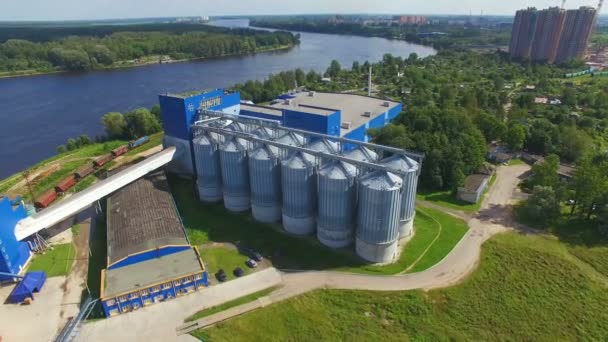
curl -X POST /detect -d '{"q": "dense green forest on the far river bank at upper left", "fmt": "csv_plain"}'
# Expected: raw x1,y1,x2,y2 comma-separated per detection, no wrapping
0,24,299,73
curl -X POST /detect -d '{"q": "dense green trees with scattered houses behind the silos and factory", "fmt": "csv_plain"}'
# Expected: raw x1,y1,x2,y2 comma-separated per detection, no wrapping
229,50,608,189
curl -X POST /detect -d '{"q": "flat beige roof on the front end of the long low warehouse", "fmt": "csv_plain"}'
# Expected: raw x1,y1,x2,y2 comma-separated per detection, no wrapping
103,248,203,298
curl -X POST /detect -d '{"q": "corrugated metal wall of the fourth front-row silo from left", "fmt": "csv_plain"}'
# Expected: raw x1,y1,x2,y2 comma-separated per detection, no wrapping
281,154,317,218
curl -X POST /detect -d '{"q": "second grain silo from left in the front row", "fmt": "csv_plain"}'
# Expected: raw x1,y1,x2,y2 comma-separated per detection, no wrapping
220,136,250,212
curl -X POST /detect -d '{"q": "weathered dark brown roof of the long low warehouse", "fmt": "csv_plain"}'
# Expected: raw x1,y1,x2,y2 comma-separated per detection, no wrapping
107,170,189,265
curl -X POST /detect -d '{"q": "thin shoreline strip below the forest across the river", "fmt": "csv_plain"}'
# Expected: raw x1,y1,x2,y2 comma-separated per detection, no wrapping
0,44,297,79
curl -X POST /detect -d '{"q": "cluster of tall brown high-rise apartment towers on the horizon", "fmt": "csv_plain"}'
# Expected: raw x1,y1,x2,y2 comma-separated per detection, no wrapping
509,7,597,63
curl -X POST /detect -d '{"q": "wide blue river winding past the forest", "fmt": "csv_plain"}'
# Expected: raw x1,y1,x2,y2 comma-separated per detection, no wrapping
0,20,435,179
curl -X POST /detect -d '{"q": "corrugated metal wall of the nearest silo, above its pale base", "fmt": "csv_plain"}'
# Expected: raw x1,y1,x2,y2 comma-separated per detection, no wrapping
357,172,402,244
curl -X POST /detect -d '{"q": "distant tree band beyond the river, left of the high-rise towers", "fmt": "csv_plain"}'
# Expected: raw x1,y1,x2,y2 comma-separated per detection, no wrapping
251,17,511,50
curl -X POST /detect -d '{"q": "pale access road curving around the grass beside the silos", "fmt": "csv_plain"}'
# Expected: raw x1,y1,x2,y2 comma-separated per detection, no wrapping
185,165,530,327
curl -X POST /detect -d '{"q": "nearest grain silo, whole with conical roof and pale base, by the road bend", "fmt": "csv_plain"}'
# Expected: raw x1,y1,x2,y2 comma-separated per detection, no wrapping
355,171,403,263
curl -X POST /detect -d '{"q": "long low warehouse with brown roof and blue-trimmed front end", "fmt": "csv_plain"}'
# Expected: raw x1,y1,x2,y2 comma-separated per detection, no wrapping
100,170,208,317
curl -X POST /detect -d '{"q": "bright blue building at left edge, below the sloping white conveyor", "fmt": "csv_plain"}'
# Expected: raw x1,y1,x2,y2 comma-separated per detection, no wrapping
0,197,32,281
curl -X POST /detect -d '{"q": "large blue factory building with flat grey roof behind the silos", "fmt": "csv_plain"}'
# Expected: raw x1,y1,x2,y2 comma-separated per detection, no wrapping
159,89,403,175
